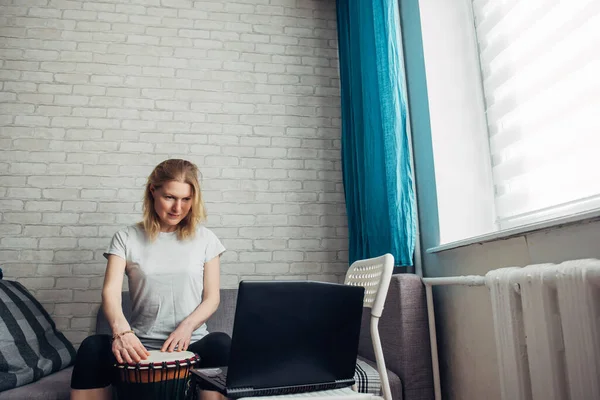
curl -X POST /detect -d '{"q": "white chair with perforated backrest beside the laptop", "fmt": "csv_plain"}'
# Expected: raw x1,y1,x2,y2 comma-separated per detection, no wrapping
344,253,394,400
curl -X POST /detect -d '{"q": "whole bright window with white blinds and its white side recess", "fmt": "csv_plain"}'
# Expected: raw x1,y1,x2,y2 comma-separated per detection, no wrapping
418,0,600,251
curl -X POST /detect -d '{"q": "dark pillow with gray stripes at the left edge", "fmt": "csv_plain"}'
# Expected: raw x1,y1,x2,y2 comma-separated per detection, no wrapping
0,280,75,392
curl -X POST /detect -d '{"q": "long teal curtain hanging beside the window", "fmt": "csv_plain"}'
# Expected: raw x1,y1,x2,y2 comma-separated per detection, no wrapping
337,0,416,266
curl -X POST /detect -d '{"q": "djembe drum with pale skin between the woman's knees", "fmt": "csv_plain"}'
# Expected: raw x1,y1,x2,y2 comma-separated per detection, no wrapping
115,350,200,400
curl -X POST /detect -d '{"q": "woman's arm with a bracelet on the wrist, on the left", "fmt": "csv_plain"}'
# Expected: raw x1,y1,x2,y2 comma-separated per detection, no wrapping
102,254,150,364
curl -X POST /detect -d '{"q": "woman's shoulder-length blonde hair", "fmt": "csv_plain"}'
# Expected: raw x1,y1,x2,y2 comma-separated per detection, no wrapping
139,159,206,241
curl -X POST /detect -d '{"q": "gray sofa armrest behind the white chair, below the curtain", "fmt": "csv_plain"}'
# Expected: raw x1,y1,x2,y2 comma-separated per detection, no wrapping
358,274,434,400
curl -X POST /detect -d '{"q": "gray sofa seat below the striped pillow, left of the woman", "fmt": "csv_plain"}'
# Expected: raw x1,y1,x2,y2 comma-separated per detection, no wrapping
0,367,73,400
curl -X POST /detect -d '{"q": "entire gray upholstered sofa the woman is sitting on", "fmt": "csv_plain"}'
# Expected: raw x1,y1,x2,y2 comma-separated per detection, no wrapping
0,274,434,400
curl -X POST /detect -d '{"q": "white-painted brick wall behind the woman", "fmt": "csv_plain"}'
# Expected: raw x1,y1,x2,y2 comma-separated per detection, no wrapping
0,0,347,343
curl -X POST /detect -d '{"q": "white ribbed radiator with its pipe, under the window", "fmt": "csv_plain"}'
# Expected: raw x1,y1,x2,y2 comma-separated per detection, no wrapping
423,260,600,400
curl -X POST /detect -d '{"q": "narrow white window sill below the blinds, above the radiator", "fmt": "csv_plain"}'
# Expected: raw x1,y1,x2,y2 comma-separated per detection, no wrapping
427,209,600,254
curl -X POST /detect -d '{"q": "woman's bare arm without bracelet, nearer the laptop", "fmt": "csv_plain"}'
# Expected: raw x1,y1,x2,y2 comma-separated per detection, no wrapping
161,256,221,352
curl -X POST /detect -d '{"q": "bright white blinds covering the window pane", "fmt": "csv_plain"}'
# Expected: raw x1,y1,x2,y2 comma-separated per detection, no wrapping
473,0,600,228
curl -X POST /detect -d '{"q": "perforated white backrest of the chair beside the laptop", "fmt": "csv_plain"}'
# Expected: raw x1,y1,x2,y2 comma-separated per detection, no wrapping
344,253,394,317
